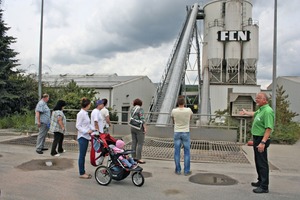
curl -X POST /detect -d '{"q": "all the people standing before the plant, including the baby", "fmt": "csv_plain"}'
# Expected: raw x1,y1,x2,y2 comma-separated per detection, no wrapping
36,92,275,193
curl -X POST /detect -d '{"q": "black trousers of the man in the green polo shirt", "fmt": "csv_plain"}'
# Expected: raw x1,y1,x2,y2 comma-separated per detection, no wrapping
253,136,270,190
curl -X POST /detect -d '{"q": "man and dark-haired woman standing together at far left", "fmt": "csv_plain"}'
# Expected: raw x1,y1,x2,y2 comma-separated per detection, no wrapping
35,94,66,156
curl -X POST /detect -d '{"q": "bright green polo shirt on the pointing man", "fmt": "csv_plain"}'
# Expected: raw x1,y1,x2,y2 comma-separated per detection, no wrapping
251,104,274,136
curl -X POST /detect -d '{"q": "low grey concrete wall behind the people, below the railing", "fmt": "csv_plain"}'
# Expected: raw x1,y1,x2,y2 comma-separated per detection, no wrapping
67,122,237,142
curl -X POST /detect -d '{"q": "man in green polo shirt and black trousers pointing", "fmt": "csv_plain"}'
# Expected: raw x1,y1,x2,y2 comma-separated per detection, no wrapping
241,92,274,193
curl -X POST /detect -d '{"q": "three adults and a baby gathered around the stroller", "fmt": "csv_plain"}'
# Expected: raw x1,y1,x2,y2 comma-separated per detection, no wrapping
76,98,146,179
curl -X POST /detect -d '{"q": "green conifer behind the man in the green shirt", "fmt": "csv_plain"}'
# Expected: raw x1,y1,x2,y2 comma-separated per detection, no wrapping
270,86,300,144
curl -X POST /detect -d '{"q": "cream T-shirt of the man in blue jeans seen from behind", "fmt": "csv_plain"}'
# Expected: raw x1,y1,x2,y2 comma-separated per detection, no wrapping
171,108,193,132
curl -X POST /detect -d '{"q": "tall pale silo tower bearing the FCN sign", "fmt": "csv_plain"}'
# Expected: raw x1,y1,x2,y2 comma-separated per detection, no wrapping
200,0,259,124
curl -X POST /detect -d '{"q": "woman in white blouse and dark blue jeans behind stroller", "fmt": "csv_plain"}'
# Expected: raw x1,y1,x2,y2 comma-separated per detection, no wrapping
76,98,93,179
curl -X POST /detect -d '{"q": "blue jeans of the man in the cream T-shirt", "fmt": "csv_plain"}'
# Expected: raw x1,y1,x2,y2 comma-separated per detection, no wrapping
174,132,191,174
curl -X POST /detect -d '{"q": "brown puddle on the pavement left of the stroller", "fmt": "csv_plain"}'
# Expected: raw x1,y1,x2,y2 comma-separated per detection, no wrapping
16,158,74,171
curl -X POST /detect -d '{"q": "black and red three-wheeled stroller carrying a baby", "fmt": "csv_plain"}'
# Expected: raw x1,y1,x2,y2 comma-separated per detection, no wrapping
95,145,145,187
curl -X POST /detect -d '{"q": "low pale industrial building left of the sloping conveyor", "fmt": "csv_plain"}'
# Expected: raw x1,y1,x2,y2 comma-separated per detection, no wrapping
43,74,156,122
